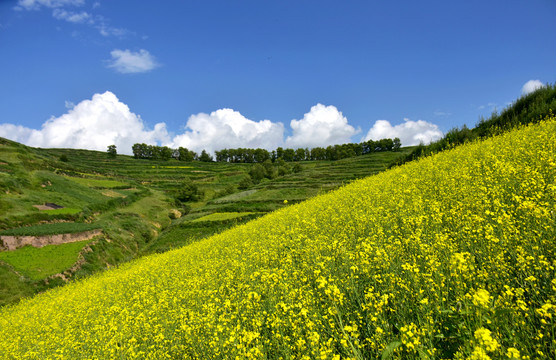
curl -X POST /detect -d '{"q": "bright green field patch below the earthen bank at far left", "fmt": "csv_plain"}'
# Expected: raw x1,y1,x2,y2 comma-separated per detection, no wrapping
0,240,89,280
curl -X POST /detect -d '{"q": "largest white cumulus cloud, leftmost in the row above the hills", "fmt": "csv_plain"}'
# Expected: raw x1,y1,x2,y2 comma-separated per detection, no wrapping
0,91,169,154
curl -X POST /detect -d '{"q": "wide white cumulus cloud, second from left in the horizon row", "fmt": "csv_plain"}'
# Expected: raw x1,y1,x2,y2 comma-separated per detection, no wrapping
171,109,284,152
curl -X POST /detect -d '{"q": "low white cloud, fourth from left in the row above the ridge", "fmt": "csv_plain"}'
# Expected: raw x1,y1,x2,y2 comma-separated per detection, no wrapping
363,118,443,146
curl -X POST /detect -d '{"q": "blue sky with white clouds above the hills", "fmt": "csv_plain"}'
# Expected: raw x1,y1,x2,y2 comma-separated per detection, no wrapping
0,0,556,153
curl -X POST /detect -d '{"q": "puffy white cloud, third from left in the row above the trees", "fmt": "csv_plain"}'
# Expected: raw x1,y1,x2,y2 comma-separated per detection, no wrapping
286,104,360,148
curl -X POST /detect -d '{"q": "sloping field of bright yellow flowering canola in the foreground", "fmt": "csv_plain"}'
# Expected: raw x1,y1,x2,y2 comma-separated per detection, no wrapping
0,117,556,359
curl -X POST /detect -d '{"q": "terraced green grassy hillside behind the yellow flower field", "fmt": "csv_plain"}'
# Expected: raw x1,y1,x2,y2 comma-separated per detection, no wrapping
0,135,410,306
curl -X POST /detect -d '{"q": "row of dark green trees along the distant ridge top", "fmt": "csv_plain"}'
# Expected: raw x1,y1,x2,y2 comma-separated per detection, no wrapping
132,138,401,163
